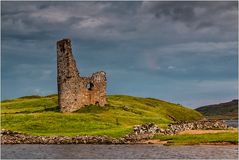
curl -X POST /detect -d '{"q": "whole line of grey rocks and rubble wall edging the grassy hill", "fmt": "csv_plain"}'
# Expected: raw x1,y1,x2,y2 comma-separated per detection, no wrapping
1,120,228,144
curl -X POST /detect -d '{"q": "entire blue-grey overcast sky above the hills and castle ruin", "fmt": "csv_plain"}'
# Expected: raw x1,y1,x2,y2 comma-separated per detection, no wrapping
1,1,238,108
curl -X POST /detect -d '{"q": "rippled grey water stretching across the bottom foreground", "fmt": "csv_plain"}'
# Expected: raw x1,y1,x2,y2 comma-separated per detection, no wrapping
1,144,238,159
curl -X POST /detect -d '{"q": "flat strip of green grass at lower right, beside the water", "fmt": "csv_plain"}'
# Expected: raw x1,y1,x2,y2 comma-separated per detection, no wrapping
153,132,238,145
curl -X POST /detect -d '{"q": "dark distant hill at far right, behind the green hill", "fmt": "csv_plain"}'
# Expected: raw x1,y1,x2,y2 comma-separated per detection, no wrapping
196,99,238,119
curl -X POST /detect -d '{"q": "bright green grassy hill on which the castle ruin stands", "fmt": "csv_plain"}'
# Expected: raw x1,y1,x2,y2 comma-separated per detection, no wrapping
1,95,202,137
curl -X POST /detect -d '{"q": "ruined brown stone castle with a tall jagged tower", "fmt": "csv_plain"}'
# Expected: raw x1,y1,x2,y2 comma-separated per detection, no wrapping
57,39,106,112
